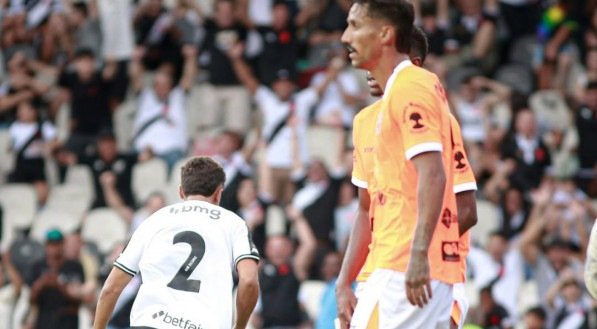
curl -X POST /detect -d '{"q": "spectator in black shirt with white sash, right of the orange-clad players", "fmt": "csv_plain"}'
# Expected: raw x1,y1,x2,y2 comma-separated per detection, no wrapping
502,108,551,193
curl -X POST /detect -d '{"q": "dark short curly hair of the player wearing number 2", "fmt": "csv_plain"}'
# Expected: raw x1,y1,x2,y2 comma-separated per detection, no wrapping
180,157,226,197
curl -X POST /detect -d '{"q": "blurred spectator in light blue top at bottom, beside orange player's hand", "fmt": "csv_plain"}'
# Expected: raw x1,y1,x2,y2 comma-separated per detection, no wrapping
314,252,342,329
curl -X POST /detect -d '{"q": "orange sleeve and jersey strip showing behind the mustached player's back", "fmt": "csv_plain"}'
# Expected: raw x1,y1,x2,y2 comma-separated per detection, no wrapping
450,114,477,282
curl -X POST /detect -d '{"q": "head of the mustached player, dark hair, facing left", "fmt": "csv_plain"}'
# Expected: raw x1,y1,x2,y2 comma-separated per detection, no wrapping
342,0,414,70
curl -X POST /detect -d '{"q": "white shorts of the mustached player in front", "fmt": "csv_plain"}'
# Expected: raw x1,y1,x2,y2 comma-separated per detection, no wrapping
350,269,453,329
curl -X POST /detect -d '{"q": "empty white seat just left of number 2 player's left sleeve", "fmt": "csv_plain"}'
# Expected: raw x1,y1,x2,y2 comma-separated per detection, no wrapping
81,208,127,255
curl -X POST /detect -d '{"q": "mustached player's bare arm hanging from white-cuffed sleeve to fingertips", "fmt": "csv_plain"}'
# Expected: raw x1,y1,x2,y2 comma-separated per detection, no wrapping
406,152,446,307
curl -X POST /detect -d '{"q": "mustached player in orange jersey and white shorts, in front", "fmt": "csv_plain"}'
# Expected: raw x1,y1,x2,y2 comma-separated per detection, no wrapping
342,0,474,328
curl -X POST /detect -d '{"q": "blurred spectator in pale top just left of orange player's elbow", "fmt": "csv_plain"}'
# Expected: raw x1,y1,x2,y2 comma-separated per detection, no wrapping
334,179,359,252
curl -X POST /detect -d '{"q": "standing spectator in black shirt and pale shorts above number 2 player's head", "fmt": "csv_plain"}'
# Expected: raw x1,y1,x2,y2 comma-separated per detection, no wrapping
199,0,250,134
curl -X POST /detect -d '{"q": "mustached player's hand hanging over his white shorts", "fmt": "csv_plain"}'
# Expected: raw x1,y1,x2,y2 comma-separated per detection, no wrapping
406,252,432,308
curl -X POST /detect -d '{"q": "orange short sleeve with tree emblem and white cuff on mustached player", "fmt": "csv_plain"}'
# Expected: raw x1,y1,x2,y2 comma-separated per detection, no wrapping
390,83,444,160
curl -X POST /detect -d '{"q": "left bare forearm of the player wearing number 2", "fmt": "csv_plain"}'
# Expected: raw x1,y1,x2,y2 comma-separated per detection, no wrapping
93,267,133,329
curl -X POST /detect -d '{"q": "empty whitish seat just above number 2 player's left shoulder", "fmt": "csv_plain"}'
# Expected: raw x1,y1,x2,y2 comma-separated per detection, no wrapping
132,158,168,203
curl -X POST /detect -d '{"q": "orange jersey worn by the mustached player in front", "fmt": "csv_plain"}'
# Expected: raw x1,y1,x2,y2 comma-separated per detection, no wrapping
371,61,462,283
